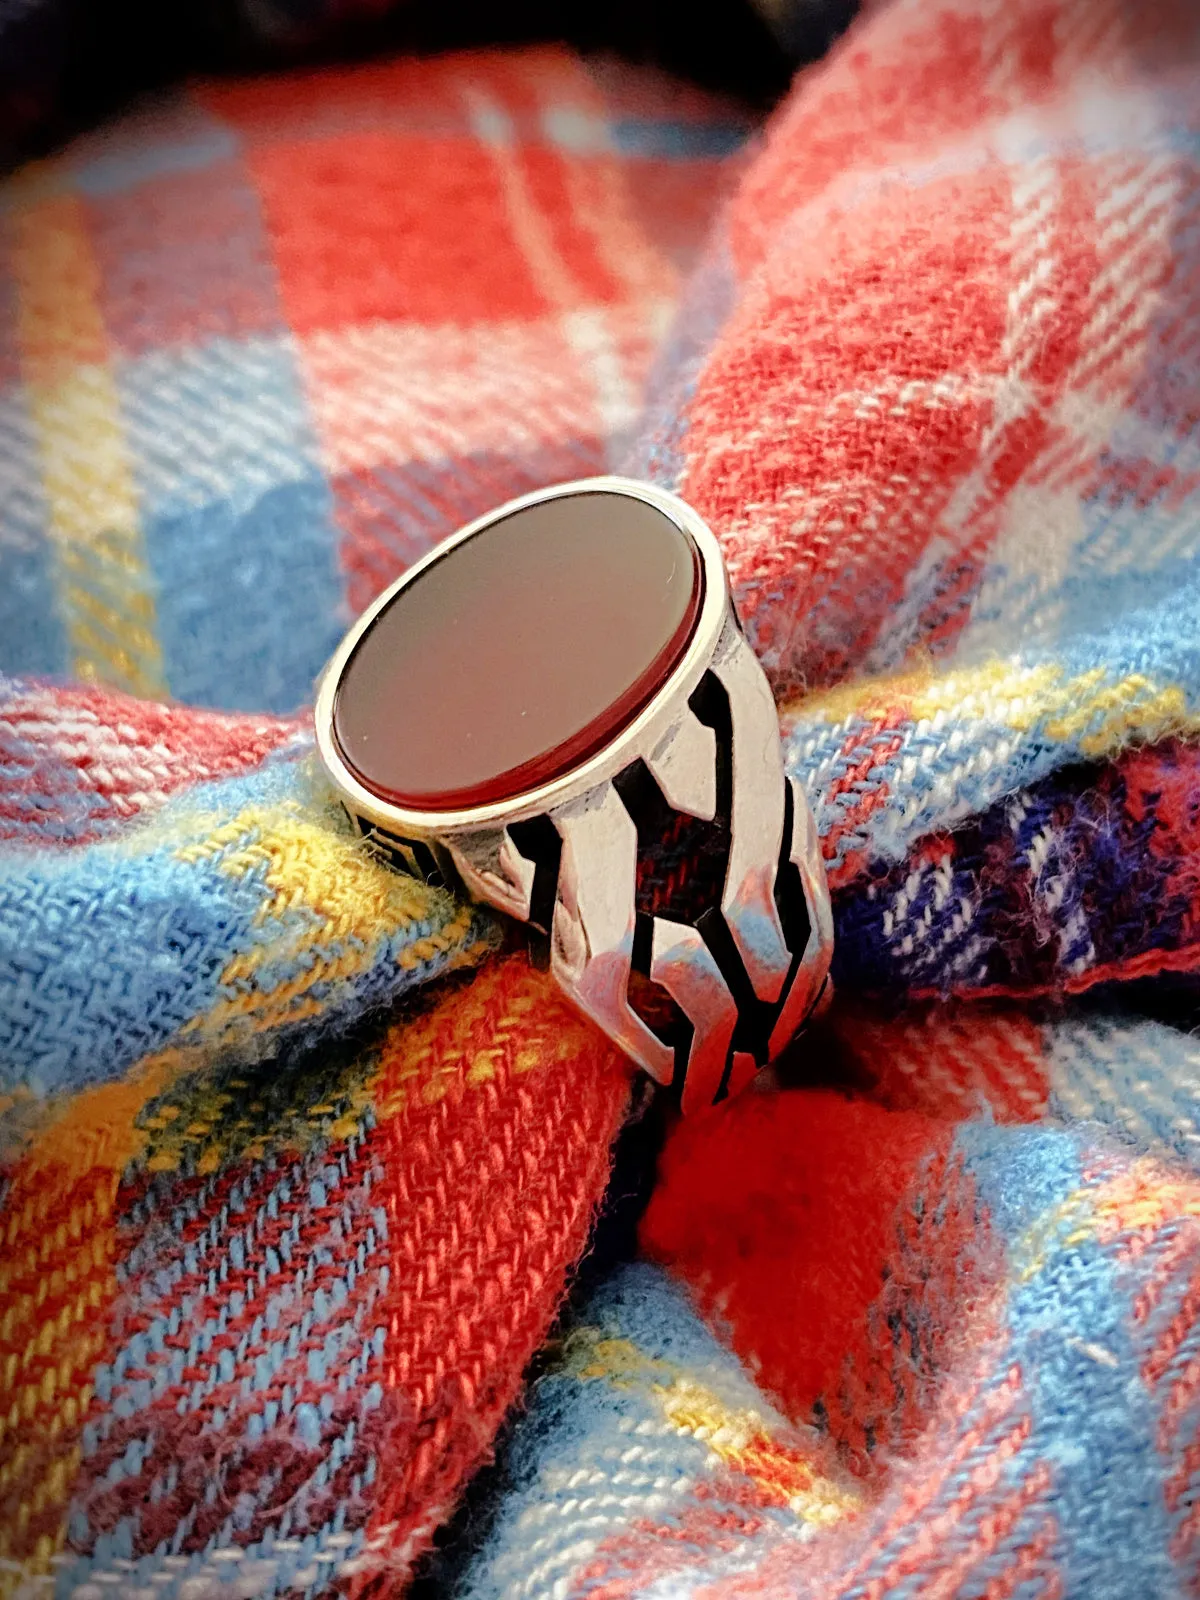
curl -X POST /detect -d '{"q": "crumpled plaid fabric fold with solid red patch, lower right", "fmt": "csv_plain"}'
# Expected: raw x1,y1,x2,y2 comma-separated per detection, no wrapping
462,1011,1200,1600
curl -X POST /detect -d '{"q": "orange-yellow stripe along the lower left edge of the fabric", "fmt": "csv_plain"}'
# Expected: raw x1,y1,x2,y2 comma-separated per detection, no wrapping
0,1058,170,1600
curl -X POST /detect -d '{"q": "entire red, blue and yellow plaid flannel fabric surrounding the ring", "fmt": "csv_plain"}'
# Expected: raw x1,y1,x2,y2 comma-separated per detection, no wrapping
0,0,1200,1600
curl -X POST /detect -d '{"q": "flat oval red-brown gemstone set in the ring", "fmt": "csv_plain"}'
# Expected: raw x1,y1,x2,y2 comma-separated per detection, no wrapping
333,491,702,811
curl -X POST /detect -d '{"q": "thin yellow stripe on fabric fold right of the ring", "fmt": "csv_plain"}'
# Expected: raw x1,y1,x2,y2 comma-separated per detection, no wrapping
782,661,1200,758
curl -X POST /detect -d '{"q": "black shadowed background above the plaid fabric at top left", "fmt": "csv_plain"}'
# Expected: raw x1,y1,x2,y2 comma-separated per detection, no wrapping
0,0,854,162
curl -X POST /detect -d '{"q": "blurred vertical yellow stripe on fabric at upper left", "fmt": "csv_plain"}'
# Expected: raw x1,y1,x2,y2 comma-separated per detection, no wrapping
10,179,166,696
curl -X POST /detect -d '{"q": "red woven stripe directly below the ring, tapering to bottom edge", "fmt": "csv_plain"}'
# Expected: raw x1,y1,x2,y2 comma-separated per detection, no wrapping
347,958,630,1595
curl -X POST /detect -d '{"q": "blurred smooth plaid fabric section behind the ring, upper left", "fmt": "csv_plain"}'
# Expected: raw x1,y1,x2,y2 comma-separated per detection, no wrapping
0,46,750,712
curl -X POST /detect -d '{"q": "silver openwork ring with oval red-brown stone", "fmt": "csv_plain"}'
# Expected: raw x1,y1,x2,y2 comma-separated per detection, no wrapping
315,477,834,1110
